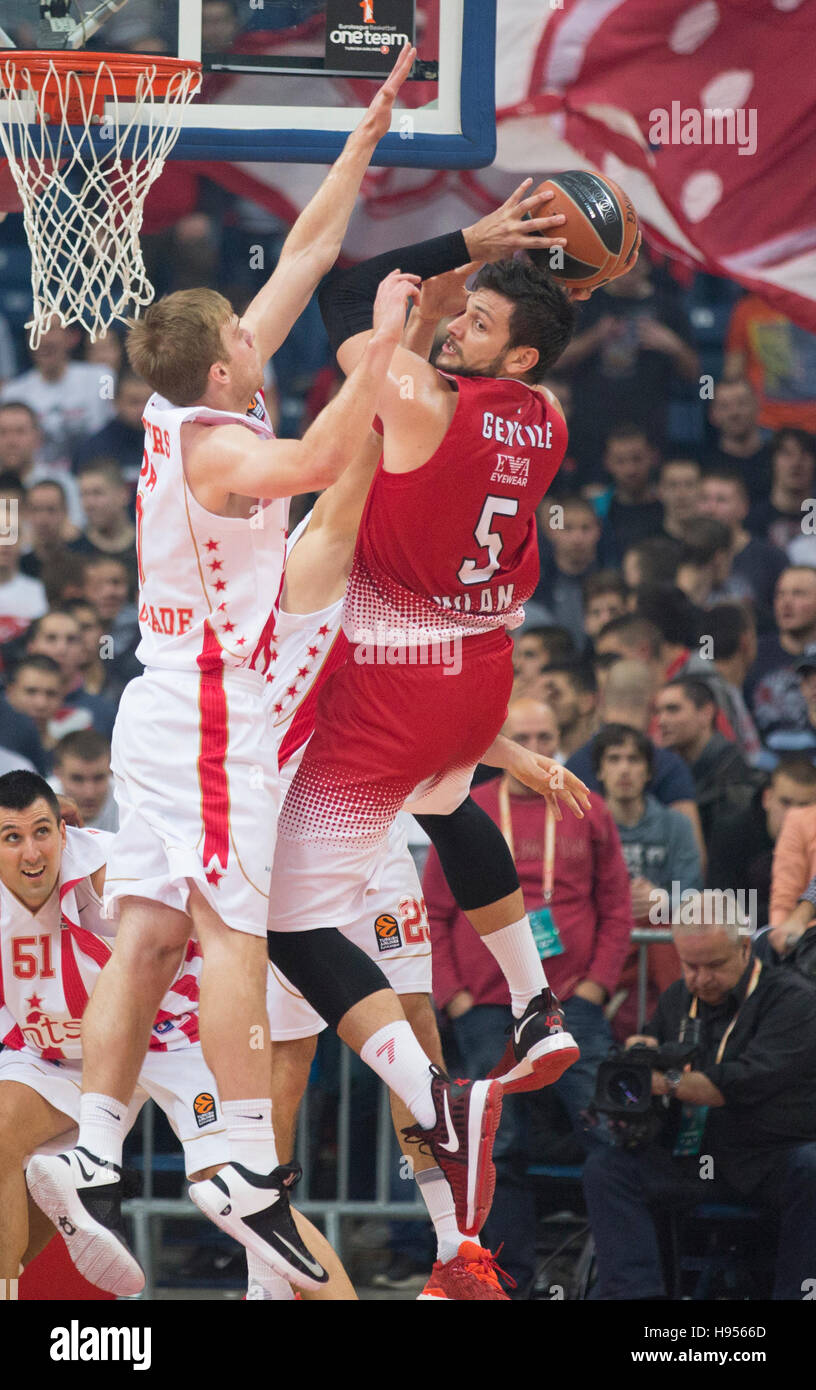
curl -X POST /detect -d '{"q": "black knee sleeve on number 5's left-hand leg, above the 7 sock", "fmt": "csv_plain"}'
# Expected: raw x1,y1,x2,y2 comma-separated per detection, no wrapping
267,927,391,1029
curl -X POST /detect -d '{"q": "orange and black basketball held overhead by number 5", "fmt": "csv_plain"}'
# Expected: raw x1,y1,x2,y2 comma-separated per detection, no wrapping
532,170,639,289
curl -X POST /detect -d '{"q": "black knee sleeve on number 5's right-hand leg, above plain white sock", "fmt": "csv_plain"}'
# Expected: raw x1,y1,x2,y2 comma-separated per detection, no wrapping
417,796,519,912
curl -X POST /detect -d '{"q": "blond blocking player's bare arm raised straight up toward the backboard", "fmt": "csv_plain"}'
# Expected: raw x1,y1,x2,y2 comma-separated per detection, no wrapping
242,47,417,361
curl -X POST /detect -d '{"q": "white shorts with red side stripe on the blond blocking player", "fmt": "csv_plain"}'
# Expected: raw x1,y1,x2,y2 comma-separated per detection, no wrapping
104,667,281,937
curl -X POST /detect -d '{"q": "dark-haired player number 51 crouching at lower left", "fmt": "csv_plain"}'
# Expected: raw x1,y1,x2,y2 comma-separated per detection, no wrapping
0,771,350,1298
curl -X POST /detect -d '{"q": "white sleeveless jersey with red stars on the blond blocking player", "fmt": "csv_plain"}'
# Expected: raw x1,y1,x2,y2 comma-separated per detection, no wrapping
136,395,289,673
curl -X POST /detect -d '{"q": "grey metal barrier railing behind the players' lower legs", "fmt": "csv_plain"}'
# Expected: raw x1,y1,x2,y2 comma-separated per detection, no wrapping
124,929,671,1298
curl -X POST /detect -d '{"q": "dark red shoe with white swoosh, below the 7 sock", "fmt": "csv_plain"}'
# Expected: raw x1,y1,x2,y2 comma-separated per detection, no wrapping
403,1066,502,1236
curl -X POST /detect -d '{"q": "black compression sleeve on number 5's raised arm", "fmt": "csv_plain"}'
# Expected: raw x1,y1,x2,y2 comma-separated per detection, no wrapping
318,232,470,353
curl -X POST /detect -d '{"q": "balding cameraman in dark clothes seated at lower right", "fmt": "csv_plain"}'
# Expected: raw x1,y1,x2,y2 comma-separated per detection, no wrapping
584,917,816,1300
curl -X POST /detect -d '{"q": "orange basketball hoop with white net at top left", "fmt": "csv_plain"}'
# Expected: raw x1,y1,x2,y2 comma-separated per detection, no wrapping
0,49,202,348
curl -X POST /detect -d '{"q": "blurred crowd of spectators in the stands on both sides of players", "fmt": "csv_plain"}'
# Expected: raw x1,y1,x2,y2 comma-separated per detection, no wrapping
0,154,816,1297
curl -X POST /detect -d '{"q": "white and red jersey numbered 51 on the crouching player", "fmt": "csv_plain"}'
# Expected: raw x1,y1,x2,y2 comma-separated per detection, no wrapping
0,826,200,1061
